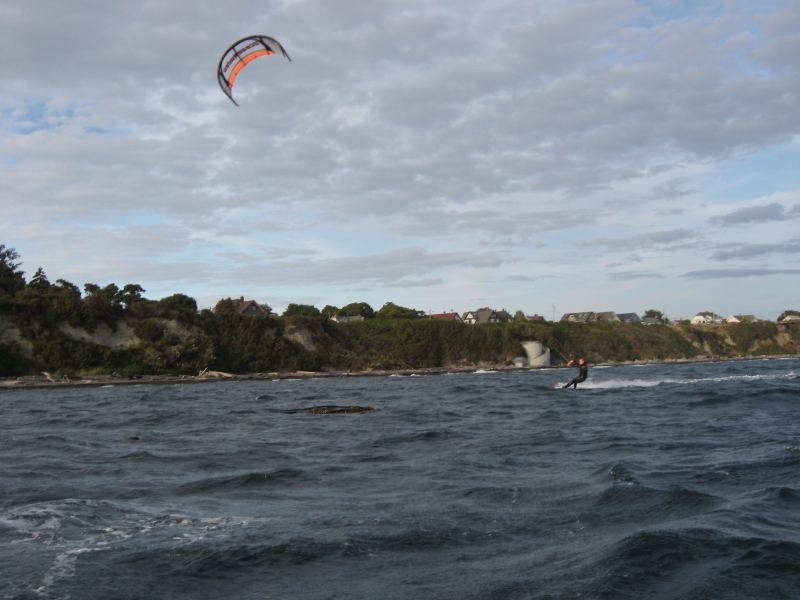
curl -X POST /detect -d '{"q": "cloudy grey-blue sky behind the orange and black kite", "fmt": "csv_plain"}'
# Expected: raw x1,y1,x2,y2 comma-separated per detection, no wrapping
0,0,800,319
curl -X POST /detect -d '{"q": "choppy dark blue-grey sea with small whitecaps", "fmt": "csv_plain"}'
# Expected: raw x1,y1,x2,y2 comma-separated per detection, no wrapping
0,359,800,600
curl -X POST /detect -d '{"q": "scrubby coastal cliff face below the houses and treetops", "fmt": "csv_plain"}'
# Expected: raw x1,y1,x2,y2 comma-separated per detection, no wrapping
0,311,800,377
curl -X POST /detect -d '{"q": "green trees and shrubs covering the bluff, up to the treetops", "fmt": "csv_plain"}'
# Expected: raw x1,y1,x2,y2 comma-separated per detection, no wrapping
0,245,800,376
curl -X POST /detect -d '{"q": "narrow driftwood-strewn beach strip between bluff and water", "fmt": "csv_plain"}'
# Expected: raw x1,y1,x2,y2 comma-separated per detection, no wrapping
0,354,800,390
